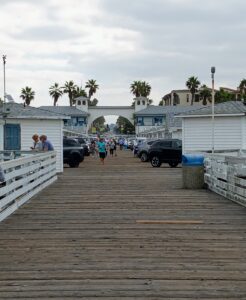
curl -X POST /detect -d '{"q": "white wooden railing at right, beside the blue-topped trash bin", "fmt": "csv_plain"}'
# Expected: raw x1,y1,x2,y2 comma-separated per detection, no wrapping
204,154,246,206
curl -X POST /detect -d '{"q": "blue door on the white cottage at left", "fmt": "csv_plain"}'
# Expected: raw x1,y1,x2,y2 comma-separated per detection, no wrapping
4,124,21,150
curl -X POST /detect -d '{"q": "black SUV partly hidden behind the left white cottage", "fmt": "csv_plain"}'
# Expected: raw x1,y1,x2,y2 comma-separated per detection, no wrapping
63,138,84,168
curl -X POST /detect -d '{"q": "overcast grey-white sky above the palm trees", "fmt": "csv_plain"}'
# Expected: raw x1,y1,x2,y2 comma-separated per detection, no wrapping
0,0,246,112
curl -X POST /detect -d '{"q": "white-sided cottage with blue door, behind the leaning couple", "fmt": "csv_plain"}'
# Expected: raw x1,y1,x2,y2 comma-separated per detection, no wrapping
0,103,70,172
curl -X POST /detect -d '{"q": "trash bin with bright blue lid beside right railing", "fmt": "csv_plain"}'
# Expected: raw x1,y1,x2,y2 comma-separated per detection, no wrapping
182,154,204,189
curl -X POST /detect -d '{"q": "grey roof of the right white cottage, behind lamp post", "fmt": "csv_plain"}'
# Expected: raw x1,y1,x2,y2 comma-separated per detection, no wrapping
181,101,246,117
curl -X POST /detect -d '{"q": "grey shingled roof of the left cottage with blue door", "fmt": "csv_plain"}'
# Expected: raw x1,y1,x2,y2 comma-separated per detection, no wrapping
0,102,69,120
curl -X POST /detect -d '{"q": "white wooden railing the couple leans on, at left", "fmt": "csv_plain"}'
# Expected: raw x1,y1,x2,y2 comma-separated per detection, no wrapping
0,151,57,221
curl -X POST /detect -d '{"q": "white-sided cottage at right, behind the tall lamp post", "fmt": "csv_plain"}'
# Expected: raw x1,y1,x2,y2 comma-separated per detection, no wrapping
177,101,246,153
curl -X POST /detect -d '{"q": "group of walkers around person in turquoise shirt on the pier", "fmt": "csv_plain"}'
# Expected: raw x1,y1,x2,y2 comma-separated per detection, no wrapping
90,138,117,164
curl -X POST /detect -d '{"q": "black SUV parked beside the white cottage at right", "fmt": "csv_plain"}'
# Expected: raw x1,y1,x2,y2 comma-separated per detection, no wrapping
148,139,182,168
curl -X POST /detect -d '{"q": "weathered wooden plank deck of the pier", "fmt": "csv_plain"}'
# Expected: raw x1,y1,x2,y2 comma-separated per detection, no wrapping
0,152,246,300
